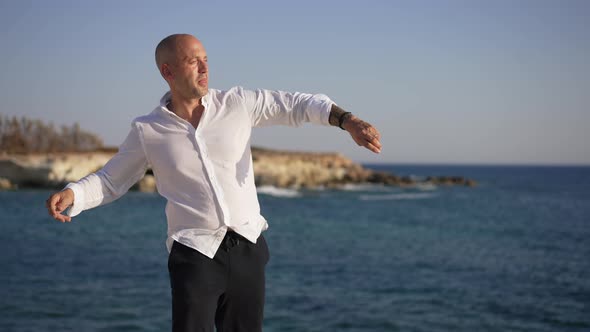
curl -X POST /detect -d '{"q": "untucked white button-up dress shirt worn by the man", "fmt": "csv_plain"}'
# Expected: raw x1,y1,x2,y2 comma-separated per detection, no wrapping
66,87,333,258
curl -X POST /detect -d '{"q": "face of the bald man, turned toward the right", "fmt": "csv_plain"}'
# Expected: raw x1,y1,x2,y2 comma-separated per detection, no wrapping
172,37,209,99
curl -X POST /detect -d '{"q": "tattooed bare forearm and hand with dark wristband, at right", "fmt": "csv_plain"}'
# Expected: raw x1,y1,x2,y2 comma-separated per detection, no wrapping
329,104,381,153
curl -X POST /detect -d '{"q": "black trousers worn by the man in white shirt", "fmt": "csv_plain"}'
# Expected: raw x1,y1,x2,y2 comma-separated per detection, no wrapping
168,231,269,332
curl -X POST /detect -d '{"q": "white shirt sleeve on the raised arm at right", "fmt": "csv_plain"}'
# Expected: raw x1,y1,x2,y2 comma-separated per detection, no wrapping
238,88,334,127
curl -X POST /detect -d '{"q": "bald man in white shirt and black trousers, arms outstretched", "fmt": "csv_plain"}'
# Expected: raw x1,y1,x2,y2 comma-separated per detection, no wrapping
47,34,381,332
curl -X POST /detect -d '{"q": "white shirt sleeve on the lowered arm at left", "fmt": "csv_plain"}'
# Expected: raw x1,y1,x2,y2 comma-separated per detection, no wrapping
66,123,148,217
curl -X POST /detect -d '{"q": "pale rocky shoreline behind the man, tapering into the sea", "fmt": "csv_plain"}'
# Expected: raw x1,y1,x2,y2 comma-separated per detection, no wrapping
0,148,477,192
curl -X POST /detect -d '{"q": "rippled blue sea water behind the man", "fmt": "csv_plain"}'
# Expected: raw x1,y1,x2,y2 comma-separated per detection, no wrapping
0,165,590,332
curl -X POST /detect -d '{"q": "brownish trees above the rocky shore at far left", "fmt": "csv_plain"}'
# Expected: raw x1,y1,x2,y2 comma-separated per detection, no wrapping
0,114,104,153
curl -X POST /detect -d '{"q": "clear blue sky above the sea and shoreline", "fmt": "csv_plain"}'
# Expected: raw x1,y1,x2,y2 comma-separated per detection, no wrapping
0,0,590,164
